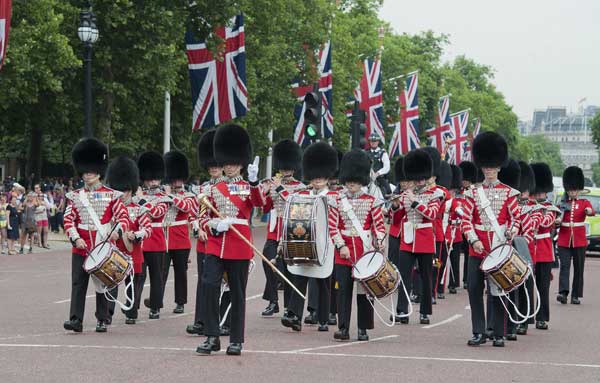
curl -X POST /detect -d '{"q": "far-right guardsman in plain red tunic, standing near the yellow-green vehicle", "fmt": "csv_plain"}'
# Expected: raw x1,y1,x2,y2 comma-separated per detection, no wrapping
556,166,596,305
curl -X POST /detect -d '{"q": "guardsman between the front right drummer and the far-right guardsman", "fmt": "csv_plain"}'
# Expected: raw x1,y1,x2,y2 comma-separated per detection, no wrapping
531,162,560,330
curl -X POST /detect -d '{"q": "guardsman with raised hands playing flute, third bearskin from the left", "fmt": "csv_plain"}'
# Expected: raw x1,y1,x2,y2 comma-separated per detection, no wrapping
134,152,172,319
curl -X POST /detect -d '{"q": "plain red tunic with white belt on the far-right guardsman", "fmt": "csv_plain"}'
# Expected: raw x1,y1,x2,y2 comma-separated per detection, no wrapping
558,198,596,247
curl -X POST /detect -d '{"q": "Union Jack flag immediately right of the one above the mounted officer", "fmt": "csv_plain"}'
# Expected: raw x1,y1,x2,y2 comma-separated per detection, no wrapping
389,72,421,157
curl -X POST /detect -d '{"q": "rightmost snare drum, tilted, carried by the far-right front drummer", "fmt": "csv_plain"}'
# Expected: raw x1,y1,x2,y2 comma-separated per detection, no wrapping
480,245,531,293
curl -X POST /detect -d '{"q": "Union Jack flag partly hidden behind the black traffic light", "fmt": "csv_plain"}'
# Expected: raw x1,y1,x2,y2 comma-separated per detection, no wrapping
292,41,333,145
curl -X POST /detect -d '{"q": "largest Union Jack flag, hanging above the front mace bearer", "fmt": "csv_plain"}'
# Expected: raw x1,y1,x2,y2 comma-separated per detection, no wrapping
185,14,248,131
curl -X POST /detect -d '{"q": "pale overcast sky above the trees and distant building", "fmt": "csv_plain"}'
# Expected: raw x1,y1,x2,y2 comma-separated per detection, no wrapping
380,0,600,120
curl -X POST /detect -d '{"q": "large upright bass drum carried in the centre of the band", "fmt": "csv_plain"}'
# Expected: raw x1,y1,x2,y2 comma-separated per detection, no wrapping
282,194,330,266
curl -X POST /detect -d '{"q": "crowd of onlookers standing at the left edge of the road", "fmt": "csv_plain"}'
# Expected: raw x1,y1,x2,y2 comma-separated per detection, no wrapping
0,178,74,255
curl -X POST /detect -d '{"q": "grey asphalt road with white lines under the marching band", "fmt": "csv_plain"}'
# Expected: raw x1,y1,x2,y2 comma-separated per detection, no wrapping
0,228,600,383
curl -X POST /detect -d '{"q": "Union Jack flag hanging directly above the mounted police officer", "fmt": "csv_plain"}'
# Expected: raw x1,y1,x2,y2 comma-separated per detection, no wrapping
354,59,385,147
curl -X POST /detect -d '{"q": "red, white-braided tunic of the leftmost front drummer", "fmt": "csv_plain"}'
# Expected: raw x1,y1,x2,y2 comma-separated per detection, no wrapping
64,183,129,256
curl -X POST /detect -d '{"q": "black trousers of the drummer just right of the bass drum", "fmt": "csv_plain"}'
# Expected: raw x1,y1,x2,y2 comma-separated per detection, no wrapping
335,265,374,330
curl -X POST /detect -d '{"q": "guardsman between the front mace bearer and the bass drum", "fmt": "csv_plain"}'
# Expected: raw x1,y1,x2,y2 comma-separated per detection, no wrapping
261,140,305,316
